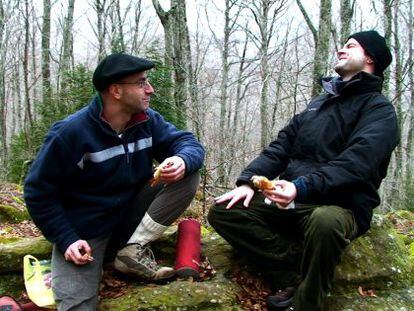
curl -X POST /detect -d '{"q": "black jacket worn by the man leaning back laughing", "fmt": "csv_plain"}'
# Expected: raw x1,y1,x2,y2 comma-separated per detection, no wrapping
237,72,399,234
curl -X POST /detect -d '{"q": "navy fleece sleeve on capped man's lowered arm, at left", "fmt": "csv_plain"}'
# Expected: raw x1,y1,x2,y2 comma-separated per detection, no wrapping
24,132,79,253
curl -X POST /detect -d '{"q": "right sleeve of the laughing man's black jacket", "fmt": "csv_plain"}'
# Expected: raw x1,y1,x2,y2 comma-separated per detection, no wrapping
298,102,399,199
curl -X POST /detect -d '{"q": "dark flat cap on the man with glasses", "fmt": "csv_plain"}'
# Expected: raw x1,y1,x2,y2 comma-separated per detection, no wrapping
92,53,154,92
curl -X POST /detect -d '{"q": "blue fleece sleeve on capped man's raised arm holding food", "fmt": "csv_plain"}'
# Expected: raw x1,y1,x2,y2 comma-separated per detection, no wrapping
150,111,204,174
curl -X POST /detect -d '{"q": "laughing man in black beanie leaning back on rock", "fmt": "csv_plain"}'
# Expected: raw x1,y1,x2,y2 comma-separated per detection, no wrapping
208,30,399,311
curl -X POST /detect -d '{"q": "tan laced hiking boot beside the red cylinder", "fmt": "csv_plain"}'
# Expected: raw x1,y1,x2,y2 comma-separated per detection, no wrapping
114,244,175,281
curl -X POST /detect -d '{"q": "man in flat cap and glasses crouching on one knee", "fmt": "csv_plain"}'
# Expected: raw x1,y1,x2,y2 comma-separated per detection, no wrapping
24,54,204,310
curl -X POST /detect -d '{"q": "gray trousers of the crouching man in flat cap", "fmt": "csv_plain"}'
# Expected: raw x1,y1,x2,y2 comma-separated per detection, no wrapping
52,173,200,311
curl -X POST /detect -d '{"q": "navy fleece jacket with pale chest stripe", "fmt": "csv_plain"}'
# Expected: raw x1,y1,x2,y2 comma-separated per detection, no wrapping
24,96,204,252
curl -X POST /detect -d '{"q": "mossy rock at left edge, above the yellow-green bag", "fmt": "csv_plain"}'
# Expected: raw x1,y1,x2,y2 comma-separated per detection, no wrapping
0,237,52,273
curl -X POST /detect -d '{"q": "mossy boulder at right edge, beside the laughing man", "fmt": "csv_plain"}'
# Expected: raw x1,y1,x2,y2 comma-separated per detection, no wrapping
335,215,414,290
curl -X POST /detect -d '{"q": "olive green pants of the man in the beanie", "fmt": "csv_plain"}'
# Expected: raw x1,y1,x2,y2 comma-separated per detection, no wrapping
208,193,357,311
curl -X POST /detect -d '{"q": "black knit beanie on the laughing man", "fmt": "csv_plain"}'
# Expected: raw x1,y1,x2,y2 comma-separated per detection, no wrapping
348,30,392,77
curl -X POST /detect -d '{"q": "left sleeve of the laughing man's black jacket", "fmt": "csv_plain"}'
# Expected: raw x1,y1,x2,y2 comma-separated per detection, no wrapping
236,114,301,186
